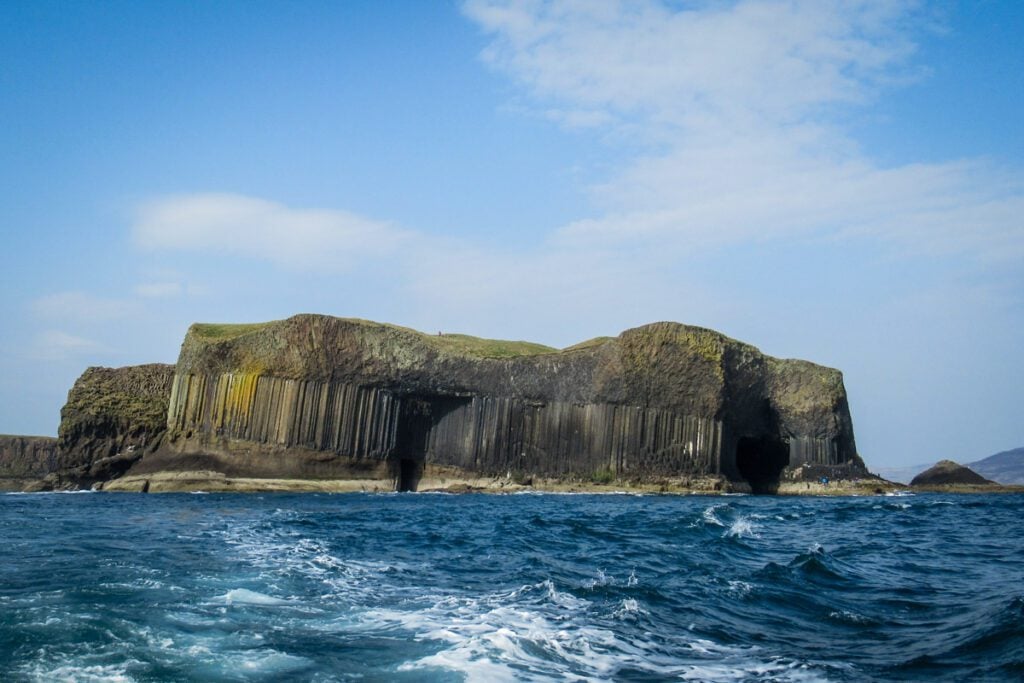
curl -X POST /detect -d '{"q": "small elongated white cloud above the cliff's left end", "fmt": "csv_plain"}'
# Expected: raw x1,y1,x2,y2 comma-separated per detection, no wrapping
133,193,409,270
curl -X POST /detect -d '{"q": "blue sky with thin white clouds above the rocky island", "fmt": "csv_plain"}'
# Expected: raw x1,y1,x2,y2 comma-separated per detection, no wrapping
0,0,1024,468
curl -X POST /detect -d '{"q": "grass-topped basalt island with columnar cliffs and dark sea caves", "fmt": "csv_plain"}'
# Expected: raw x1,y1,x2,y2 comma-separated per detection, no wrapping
19,315,868,492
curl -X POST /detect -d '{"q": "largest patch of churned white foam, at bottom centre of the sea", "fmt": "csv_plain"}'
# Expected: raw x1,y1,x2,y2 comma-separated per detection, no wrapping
360,581,797,681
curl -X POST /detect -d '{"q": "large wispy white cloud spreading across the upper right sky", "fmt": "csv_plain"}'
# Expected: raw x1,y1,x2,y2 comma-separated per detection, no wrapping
465,0,1024,262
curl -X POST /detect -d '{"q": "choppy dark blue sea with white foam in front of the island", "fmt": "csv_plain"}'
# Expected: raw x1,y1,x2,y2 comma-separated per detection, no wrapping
0,494,1024,682
